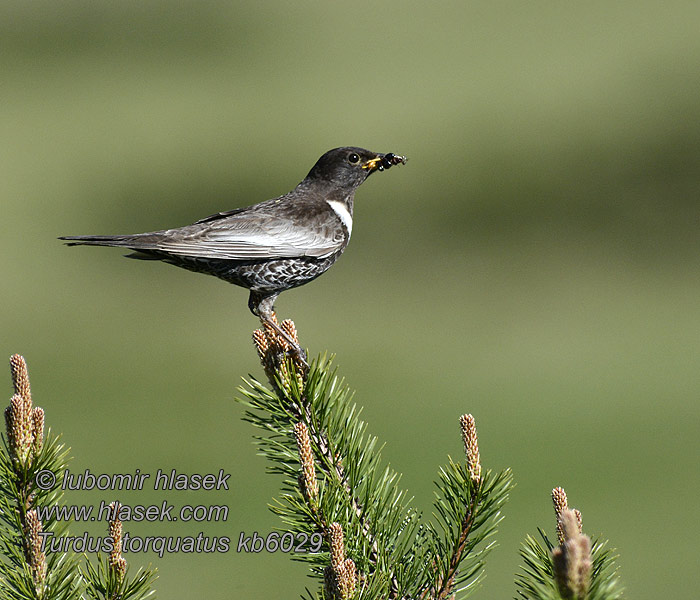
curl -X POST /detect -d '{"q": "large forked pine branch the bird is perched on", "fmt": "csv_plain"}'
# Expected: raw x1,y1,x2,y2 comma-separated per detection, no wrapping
240,321,511,600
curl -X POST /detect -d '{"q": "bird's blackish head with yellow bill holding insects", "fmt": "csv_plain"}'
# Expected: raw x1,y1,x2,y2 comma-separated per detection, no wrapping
306,146,406,191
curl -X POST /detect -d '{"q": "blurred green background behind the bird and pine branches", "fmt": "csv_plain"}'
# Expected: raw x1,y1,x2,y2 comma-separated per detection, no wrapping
0,0,700,600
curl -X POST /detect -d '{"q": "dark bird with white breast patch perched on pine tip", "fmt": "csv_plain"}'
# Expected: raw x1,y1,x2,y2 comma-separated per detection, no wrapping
64,146,407,360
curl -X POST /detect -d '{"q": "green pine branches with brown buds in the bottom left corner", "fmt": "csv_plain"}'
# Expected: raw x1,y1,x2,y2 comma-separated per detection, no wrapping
0,354,155,600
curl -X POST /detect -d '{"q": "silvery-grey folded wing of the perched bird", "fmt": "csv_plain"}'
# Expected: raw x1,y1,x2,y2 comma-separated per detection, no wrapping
154,213,345,260
